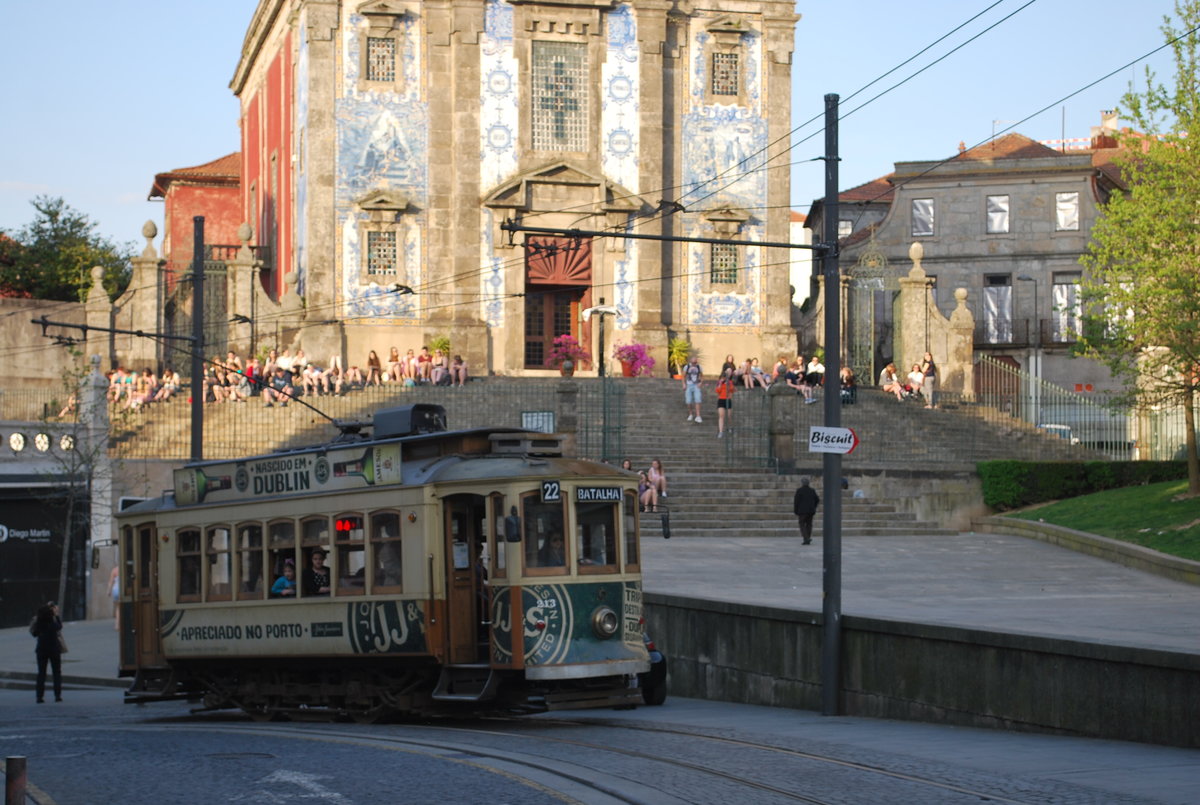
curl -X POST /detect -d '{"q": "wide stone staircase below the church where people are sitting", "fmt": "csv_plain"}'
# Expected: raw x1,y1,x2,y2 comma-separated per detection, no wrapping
114,378,1088,537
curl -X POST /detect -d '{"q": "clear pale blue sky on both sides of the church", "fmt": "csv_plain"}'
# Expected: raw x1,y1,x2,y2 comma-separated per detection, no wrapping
0,0,1174,251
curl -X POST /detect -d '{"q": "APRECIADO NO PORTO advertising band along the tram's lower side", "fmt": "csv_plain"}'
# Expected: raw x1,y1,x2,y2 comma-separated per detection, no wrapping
160,600,428,657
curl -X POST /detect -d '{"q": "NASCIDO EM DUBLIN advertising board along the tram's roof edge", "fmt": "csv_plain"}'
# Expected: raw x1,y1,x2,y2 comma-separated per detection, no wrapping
175,443,403,506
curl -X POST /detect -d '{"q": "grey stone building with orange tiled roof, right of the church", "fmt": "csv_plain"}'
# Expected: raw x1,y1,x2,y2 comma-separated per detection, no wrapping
802,115,1121,392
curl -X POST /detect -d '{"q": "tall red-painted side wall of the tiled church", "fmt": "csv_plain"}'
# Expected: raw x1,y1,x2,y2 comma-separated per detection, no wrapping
241,28,296,299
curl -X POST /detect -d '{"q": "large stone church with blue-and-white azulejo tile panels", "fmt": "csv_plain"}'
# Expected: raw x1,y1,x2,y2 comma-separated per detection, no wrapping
152,0,798,374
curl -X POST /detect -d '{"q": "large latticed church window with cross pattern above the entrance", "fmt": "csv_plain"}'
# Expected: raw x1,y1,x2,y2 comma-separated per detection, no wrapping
530,42,590,151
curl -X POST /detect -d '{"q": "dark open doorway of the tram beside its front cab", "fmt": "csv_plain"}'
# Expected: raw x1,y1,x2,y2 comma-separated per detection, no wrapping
443,494,488,663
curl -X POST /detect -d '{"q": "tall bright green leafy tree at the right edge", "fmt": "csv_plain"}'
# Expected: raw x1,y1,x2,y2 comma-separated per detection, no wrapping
1079,0,1200,495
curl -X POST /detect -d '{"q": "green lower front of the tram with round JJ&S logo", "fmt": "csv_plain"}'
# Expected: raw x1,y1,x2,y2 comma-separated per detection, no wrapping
492,582,646,668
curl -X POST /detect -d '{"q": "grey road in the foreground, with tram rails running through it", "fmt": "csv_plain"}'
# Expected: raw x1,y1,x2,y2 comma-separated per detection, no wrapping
0,681,1200,805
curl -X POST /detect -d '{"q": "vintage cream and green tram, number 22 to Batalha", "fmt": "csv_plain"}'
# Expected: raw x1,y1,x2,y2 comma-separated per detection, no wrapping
118,404,661,721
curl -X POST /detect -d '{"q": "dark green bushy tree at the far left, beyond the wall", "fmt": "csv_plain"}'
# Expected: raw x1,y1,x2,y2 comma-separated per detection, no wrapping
0,196,133,302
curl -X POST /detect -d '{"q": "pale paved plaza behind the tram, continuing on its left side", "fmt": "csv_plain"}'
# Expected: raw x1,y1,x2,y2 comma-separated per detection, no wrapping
0,525,1200,687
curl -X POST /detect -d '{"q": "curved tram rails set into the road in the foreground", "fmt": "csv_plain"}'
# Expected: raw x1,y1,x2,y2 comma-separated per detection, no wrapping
126,719,1040,805
